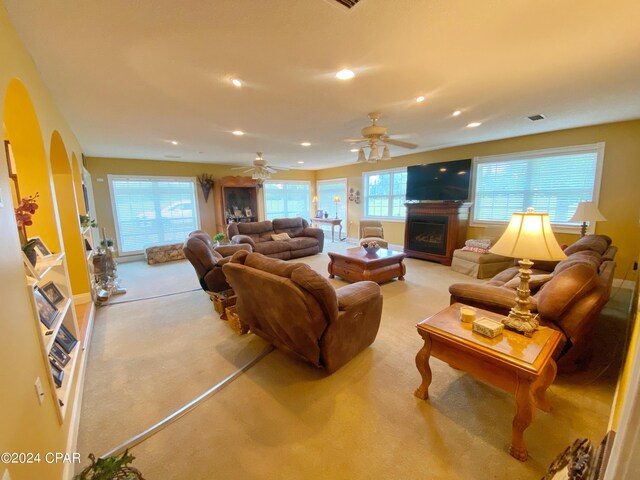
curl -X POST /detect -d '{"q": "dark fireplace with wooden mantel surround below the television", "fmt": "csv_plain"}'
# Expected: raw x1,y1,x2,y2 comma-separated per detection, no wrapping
404,202,469,265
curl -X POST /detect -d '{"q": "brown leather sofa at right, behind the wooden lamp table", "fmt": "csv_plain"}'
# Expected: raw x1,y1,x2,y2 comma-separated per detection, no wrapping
449,235,617,371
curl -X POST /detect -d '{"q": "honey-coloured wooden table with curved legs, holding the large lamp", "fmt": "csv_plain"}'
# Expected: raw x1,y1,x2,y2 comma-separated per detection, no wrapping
415,303,561,461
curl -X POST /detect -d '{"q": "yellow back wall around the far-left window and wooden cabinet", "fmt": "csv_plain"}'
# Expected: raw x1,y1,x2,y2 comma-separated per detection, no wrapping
87,157,315,255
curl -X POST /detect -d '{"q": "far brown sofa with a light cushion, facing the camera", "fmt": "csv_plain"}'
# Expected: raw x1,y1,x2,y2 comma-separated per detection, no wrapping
227,217,324,260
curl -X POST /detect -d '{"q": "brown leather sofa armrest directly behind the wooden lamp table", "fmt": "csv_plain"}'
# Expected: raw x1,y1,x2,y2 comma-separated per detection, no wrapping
449,283,538,315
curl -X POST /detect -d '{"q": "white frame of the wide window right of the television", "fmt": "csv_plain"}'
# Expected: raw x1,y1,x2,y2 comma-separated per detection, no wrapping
469,142,605,234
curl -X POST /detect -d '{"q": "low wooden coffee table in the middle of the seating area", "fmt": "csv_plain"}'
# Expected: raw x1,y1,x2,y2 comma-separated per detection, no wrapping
329,247,407,283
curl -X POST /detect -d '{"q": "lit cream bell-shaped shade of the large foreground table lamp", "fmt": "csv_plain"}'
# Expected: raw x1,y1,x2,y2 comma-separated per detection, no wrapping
489,209,567,260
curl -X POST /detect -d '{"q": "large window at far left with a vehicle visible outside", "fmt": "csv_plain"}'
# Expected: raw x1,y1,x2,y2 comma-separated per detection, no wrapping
109,175,199,254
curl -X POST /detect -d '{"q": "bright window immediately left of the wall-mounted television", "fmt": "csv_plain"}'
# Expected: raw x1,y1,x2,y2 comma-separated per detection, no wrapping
362,168,407,218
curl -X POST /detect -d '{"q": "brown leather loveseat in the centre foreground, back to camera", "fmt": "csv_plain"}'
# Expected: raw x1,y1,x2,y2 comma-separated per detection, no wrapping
222,252,382,373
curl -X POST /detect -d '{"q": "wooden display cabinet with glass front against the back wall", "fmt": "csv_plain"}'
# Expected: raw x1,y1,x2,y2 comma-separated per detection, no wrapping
213,177,259,234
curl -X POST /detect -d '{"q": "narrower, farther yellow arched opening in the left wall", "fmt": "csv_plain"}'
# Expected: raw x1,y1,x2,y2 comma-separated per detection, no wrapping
49,130,89,295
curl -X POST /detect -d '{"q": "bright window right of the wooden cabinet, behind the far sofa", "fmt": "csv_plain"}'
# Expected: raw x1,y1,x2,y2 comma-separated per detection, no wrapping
264,180,311,220
